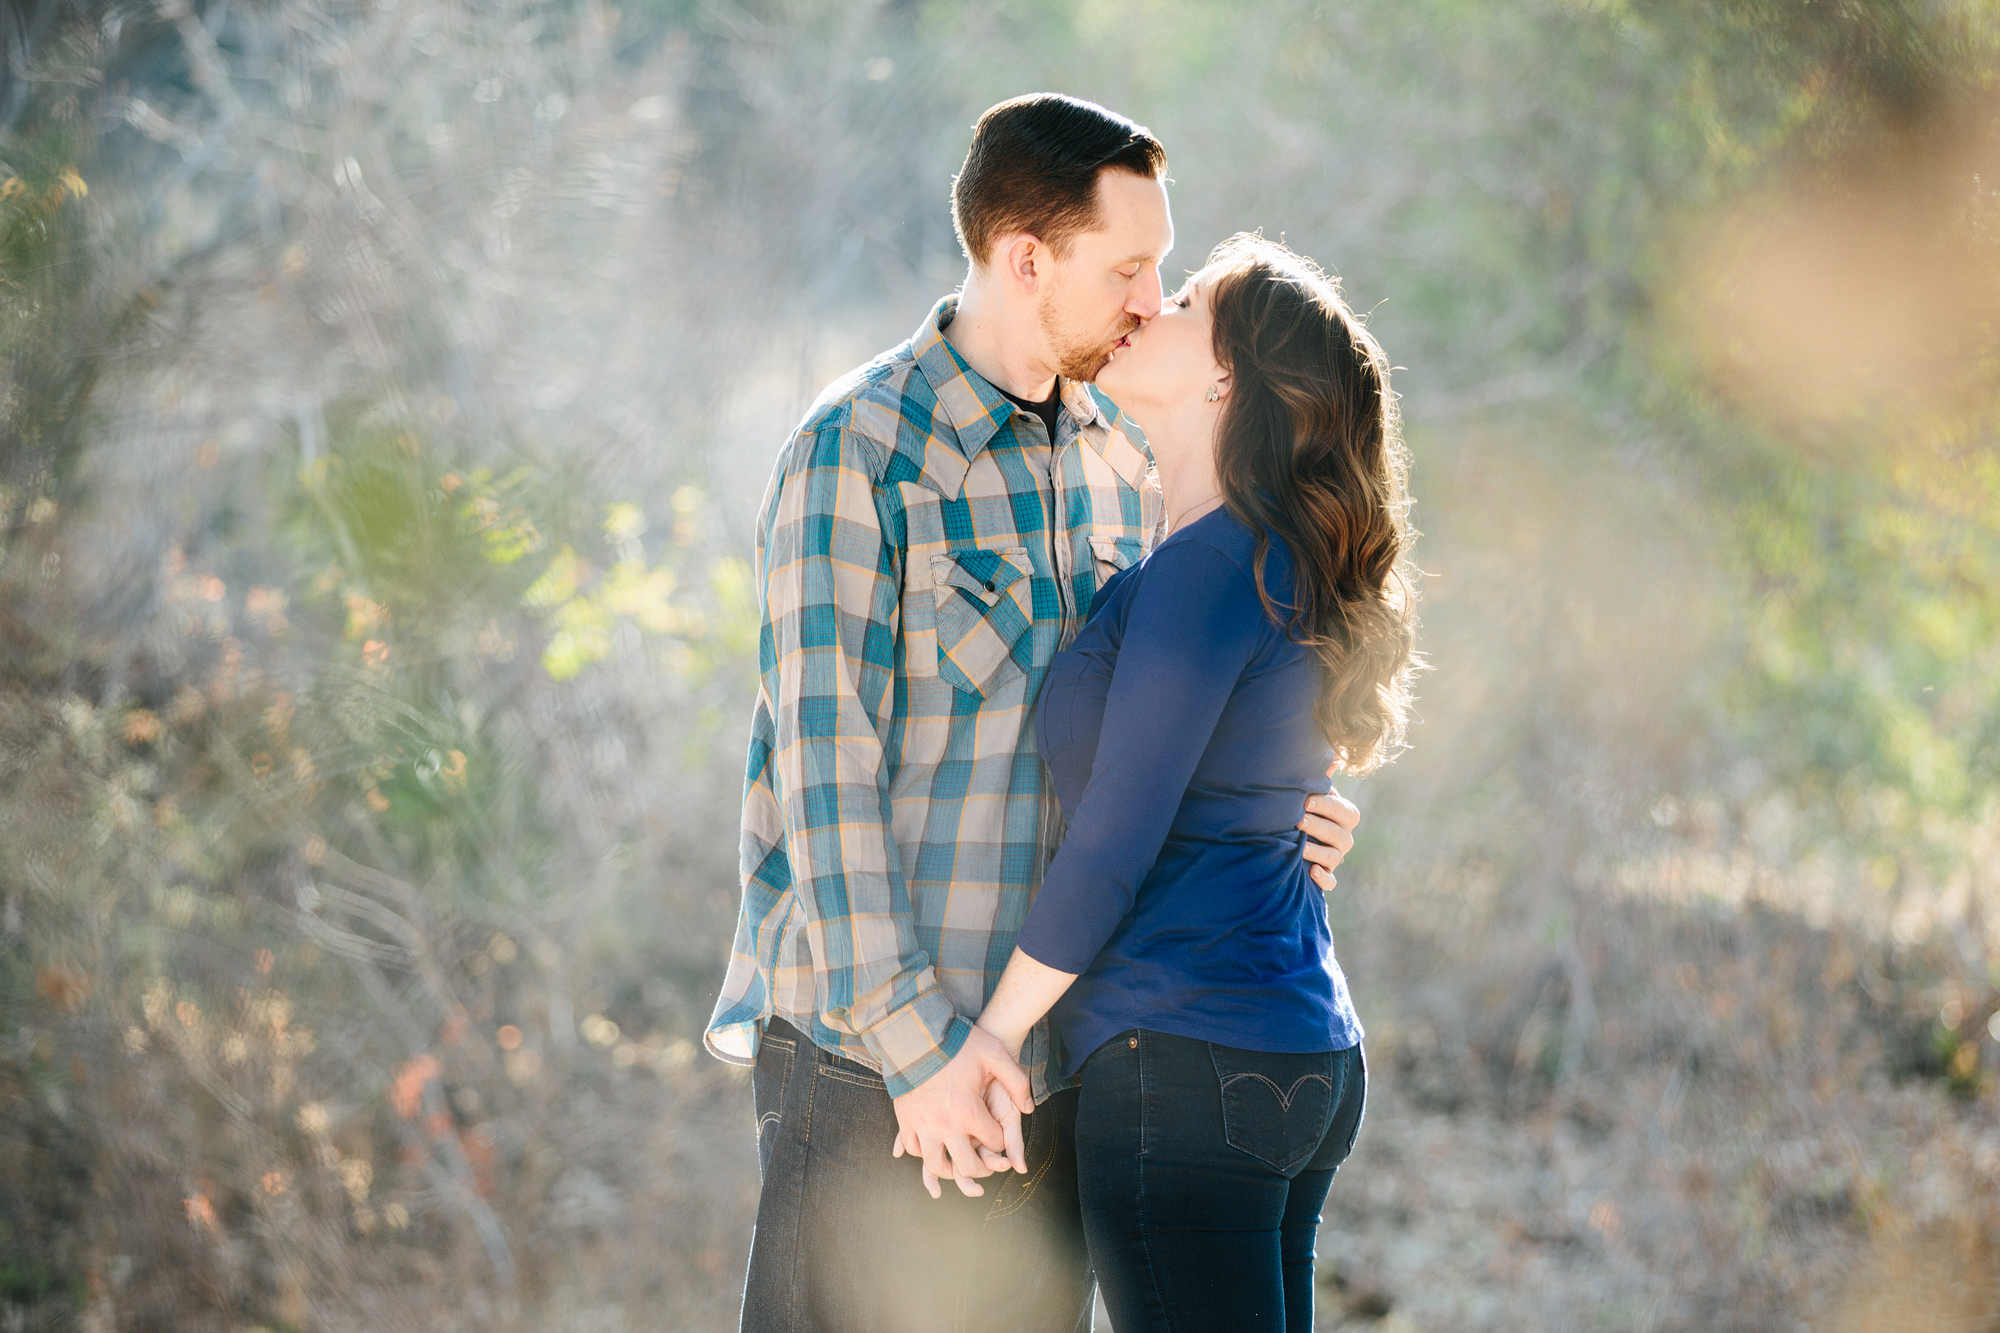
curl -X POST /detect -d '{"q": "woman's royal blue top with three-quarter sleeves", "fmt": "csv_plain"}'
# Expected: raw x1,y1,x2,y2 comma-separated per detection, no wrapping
1016,508,1362,1077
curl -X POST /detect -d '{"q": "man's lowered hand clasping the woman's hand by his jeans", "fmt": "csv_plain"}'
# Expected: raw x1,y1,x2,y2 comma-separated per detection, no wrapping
894,1027,1034,1199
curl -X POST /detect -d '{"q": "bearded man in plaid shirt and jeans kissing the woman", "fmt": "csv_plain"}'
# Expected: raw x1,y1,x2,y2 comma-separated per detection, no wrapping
708,94,1356,1333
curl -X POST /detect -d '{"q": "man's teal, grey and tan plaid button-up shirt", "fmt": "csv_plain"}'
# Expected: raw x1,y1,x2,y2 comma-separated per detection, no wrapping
706,296,1162,1101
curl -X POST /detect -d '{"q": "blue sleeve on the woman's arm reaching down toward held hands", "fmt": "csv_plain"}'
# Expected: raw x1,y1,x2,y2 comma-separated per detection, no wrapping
1016,540,1272,973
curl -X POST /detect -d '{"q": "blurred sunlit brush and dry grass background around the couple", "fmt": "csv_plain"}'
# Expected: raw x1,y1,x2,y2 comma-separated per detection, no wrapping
0,0,2000,1333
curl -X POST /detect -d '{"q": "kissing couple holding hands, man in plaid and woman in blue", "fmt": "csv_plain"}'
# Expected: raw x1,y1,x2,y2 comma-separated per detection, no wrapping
706,94,1416,1333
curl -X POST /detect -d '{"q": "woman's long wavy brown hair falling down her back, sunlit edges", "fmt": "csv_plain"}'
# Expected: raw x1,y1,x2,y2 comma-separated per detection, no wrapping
1206,232,1424,773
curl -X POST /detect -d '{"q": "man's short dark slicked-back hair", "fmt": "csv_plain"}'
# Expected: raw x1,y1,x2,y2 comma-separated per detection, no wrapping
952,92,1166,266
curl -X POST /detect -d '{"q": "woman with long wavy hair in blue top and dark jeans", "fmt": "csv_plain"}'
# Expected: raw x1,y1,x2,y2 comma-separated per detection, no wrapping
980,236,1416,1333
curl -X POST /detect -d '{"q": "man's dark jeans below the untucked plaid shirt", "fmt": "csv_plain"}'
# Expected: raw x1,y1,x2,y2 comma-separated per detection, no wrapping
742,1019,1096,1333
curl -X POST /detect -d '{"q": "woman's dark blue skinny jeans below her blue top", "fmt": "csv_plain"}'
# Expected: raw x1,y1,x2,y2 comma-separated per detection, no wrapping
1076,1031,1368,1333
